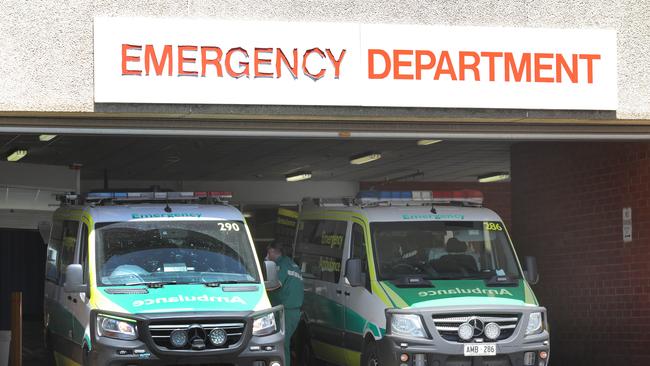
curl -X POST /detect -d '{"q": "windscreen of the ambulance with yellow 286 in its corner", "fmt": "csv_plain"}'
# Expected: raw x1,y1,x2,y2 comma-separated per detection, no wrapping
370,221,521,280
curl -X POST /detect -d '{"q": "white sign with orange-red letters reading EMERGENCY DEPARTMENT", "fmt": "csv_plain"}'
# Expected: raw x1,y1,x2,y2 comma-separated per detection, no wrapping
94,18,618,110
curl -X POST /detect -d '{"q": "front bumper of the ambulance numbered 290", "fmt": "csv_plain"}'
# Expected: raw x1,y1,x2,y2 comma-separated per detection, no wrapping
88,311,284,366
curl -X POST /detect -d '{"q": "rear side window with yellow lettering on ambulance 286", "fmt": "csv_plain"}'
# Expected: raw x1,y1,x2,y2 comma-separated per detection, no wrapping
294,220,348,283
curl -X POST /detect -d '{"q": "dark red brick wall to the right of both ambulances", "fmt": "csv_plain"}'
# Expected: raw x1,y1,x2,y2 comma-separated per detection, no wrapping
511,143,650,366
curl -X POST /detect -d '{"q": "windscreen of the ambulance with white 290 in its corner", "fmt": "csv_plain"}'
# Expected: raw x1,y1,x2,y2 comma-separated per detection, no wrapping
95,220,259,286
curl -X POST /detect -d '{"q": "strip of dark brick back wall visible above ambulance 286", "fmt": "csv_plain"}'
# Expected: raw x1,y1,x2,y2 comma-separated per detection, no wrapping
360,182,511,227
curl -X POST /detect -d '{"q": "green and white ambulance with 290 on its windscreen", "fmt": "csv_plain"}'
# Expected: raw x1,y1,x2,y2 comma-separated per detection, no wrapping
44,192,284,366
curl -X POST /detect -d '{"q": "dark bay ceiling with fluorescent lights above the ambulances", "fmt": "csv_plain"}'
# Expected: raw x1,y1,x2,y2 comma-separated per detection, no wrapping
0,134,511,181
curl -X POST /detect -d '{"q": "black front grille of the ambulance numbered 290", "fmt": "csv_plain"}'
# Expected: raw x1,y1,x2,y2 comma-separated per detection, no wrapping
149,319,246,351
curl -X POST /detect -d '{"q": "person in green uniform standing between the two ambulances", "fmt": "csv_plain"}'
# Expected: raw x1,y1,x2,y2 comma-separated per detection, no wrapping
266,242,305,366
